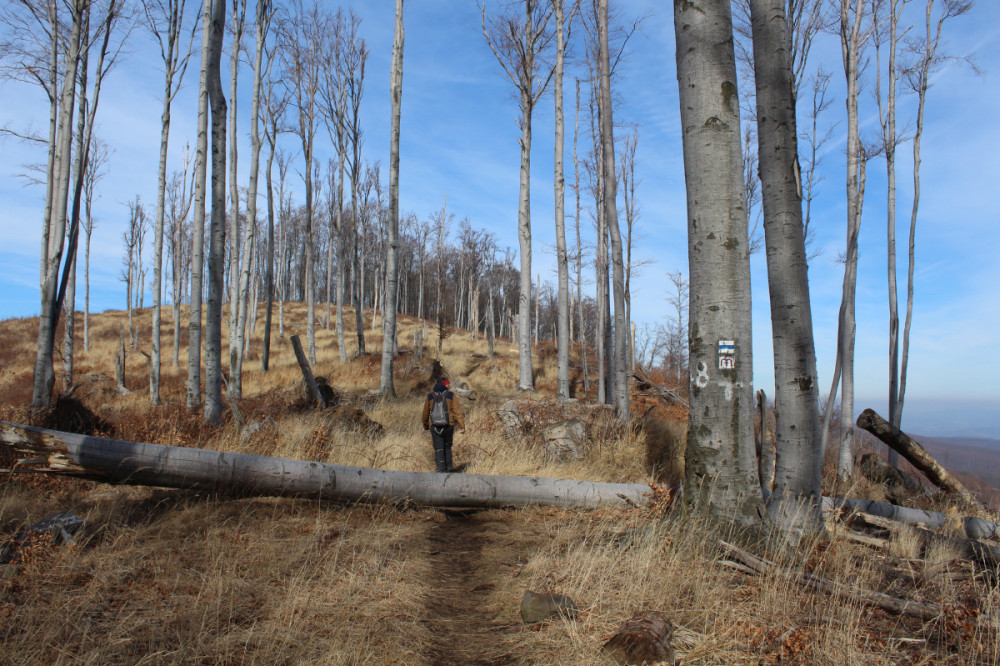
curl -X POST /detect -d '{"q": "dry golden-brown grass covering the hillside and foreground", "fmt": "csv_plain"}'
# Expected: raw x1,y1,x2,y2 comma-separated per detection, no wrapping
0,304,1000,664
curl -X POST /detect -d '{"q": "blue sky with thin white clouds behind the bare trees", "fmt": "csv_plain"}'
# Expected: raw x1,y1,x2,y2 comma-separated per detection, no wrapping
0,0,1000,438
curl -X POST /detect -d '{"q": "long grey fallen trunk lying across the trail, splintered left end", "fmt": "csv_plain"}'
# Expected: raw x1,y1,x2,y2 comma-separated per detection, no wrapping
0,421,652,508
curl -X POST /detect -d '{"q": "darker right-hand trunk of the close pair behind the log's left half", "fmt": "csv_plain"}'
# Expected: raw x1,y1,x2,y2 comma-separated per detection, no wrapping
205,0,229,425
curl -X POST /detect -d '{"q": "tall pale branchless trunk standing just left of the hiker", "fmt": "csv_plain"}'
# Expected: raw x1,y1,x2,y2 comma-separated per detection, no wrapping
378,0,404,398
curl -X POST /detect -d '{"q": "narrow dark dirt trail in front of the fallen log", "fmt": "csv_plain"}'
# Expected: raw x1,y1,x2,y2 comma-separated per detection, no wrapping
424,510,519,666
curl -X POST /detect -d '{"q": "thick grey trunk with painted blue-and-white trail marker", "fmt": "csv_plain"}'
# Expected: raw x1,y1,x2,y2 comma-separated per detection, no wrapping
674,0,764,525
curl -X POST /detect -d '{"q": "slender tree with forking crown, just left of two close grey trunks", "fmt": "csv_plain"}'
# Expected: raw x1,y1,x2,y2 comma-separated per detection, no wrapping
142,0,198,405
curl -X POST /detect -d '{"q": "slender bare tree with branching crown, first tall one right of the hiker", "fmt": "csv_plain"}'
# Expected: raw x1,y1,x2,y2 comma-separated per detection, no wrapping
483,0,554,391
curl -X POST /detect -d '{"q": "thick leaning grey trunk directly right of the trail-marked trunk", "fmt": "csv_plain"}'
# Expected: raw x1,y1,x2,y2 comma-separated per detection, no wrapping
750,0,823,531
